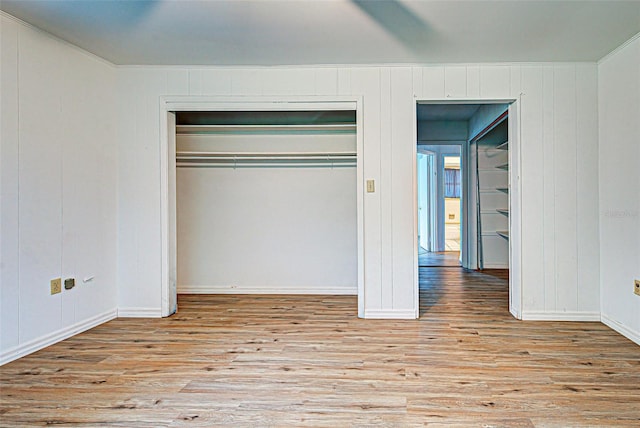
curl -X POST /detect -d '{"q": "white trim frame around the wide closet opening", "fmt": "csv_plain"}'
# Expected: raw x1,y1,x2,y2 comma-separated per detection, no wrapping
159,96,365,318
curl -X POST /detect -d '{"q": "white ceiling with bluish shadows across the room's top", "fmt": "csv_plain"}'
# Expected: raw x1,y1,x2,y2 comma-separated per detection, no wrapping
0,0,640,65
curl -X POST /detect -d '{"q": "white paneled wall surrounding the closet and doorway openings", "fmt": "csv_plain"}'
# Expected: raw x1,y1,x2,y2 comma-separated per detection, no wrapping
118,63,600,319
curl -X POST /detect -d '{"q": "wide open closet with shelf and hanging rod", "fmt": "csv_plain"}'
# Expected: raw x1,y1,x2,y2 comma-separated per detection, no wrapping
163,97,364,316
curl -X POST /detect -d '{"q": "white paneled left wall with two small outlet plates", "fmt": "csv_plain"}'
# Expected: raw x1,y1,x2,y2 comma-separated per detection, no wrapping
0,14,117,363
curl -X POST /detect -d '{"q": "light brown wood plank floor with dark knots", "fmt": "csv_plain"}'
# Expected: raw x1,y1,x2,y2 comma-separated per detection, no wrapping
0,268,640,427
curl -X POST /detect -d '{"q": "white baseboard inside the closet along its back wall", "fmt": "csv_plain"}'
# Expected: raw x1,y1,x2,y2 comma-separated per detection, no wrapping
178,285,358,295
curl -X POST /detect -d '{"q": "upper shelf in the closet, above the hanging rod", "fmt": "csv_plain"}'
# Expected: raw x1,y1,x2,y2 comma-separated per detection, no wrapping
176,124,356,135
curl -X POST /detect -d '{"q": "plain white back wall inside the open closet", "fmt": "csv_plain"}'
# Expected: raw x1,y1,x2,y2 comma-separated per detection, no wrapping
177,131,358,294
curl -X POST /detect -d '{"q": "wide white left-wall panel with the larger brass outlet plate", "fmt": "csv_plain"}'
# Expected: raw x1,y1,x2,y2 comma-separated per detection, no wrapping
18,27,64,342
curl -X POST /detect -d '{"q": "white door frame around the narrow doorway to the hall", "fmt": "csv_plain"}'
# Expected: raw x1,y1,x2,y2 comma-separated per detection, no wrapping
412,96,523,319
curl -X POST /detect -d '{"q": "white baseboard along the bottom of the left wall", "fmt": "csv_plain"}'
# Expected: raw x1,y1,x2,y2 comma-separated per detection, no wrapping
0,309,118,366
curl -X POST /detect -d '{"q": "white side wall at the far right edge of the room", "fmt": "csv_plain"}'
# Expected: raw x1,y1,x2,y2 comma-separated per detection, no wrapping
600,37,640,344
